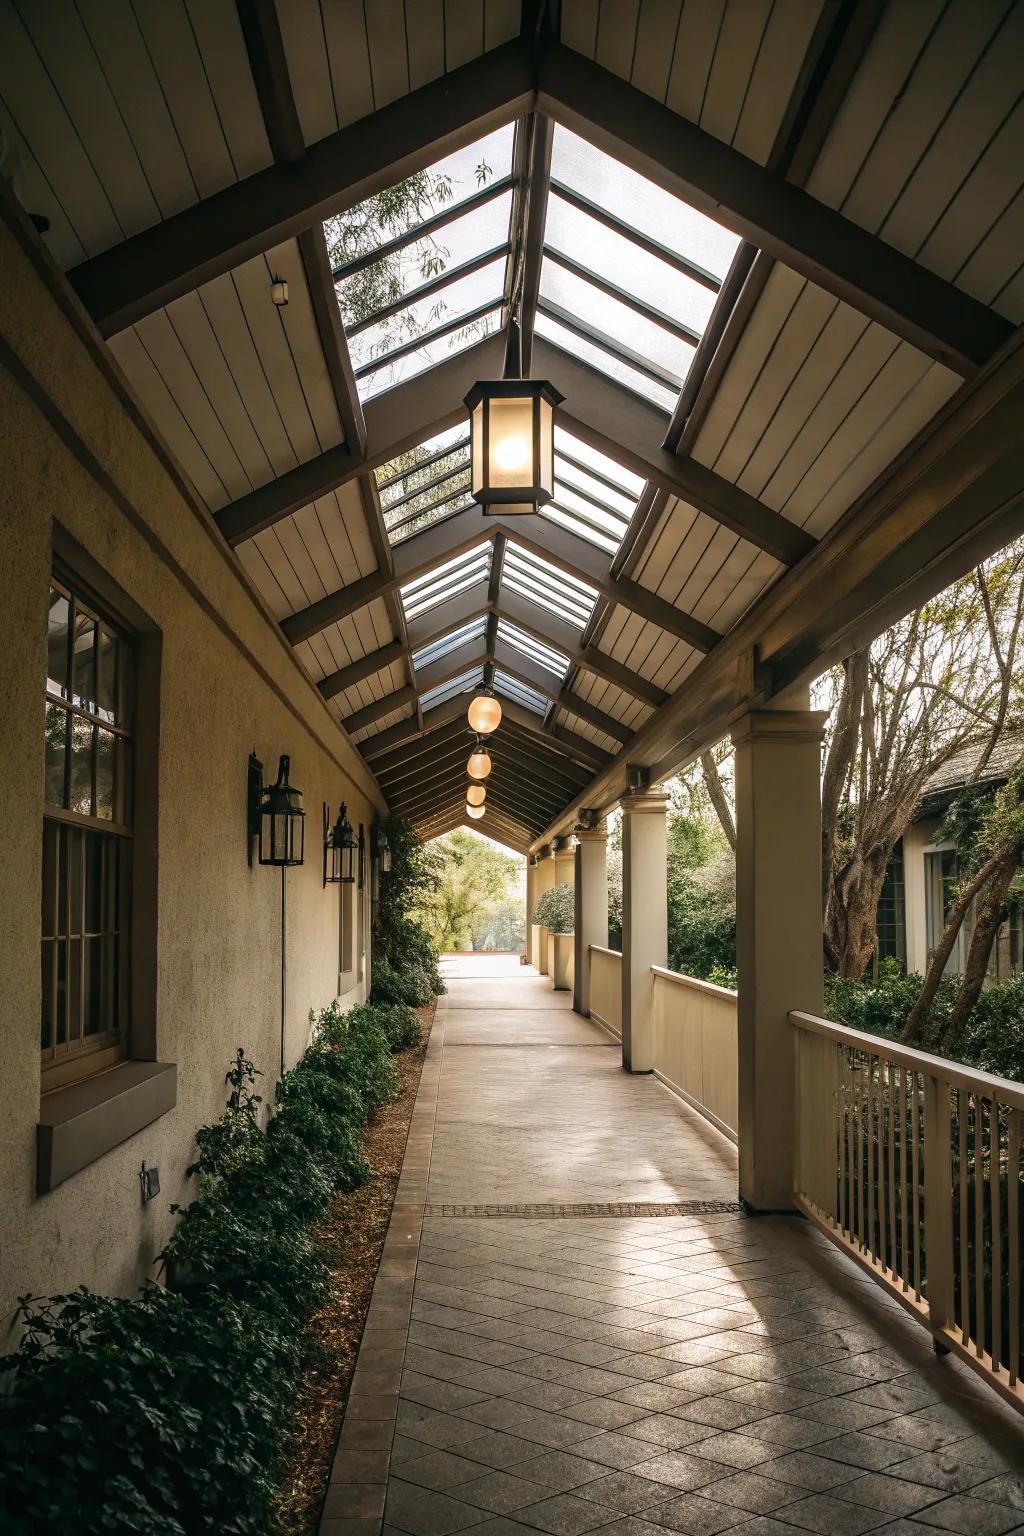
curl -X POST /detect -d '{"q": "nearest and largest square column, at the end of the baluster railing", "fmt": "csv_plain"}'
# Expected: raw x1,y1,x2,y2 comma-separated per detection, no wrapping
732,710,826,1210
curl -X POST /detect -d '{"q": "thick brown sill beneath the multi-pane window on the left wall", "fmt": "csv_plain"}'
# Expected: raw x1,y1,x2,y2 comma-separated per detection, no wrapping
35,1061,178,1195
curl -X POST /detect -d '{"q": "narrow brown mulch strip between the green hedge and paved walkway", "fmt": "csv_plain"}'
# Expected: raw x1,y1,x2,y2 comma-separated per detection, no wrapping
274,1003,436,1536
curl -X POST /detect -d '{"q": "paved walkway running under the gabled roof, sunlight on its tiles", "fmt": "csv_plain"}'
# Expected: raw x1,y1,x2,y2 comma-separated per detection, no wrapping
321,955,1024,1536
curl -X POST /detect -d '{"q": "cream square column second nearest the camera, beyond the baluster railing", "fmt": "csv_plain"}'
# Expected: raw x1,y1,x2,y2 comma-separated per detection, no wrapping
622,788,668,1072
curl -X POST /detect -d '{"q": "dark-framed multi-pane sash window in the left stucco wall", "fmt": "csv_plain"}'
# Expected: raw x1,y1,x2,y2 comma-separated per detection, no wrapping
40,581,134,1089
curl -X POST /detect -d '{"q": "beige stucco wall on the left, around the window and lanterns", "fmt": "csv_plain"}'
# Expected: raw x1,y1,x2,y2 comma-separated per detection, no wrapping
0,204,384,1347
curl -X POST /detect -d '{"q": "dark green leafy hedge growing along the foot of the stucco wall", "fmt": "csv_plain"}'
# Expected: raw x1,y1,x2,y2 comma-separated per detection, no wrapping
0,1005,419,1536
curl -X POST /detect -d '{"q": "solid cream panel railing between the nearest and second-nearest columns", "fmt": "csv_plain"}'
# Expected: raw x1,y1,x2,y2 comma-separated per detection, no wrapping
651,965,738,1141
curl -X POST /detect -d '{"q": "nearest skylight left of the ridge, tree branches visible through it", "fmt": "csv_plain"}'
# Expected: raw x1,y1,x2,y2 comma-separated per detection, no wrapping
324,124,514,399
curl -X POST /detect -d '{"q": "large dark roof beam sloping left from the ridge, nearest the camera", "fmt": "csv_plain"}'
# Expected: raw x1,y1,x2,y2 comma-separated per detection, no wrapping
69,40,534,336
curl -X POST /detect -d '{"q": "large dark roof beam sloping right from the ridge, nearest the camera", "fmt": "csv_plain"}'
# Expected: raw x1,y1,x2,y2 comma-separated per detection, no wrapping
539,43,1012,376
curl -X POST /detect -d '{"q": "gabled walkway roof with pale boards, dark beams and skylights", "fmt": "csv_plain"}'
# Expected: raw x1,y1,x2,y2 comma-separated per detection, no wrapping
0,0,1024,846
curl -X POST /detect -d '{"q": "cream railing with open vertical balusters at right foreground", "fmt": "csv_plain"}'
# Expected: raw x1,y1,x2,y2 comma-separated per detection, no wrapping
789,1014,1024,1410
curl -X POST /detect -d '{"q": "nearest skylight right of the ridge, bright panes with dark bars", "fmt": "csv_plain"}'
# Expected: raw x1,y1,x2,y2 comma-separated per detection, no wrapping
536,126,738,410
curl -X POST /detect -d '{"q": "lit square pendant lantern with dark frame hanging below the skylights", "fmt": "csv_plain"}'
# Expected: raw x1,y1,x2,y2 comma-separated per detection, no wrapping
465,379,565,516
